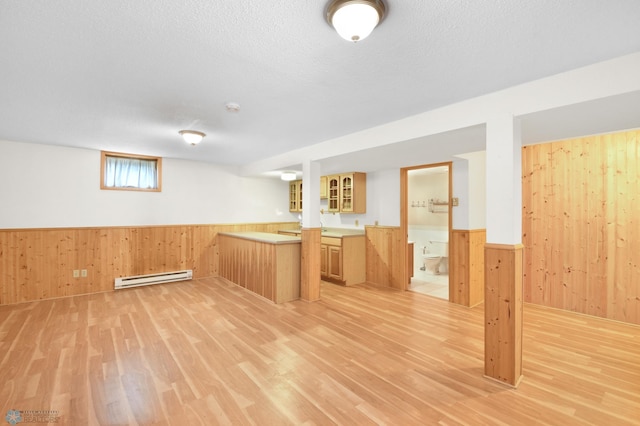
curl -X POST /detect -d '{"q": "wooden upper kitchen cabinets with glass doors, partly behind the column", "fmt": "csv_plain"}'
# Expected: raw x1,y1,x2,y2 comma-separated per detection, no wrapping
289,172,367,213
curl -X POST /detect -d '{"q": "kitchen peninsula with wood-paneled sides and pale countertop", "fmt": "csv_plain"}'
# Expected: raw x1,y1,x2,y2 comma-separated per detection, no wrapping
218,232,301,303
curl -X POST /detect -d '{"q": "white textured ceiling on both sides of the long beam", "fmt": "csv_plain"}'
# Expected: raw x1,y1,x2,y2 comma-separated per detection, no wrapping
0,0,640,175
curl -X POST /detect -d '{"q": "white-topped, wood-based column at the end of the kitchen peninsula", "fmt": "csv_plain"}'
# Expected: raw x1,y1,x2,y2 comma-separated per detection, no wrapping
300,160,322,302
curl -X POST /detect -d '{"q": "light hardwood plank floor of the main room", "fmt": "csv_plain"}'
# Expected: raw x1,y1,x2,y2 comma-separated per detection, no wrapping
0,278,640,426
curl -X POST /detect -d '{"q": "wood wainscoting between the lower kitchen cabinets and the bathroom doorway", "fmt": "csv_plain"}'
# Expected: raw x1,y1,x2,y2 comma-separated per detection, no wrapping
365,226,407,290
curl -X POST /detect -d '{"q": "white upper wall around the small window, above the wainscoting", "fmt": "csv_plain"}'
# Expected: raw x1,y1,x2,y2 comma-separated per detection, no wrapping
0,141,291,229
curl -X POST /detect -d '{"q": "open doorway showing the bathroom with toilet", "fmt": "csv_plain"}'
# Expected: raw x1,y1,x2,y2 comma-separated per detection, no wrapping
401,163,452,300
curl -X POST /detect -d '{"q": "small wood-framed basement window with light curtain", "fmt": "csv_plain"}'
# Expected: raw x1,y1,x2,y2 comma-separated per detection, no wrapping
100,151,162,192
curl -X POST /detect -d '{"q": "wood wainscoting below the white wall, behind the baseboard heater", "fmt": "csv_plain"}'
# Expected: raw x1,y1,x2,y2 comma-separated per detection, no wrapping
0,222,298,304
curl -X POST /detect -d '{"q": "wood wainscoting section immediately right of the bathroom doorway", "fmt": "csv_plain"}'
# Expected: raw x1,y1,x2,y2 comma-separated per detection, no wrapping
449,229,487,307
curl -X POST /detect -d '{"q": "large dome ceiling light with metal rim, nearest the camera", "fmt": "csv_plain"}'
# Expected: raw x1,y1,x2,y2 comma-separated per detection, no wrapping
327,0,386,43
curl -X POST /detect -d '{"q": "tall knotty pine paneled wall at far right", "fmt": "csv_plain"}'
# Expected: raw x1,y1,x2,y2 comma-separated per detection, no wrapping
522,130,640,324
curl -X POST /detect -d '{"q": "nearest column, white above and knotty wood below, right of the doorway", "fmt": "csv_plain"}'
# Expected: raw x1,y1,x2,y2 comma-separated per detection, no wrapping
484,113,522,387
